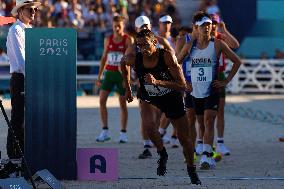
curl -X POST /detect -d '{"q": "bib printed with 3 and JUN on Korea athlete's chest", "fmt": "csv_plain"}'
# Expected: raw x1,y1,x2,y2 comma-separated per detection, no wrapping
191,67,212,82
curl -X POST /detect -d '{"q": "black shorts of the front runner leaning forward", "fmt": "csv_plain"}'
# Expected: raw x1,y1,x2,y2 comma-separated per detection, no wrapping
141,91,185,119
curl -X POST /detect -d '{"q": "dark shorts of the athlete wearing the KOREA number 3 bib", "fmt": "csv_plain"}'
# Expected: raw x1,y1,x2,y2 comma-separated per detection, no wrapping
192,93,220,115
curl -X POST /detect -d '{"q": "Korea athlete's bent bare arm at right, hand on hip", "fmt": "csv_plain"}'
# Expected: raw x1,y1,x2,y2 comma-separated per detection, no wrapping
213,39,242,88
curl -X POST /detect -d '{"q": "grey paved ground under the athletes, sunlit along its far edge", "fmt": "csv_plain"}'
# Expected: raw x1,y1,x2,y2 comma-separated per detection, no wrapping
0,95,284,189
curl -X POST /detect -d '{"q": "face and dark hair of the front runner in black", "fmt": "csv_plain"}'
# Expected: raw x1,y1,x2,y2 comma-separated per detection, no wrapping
136,37,155,56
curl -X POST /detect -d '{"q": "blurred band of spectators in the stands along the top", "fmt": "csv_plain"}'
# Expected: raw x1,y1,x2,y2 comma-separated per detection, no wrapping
0,0,180,30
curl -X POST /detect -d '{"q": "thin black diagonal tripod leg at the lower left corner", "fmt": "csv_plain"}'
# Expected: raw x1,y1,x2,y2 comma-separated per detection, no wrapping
0,99,37,189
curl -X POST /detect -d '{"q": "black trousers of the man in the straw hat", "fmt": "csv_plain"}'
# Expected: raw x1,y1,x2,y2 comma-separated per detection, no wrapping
7,73,25,159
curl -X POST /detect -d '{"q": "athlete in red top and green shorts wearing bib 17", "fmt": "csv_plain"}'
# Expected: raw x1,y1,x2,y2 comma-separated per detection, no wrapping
96,16,133,143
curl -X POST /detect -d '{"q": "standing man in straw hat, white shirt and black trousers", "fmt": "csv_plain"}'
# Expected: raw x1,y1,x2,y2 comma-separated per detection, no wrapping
6,0,40,158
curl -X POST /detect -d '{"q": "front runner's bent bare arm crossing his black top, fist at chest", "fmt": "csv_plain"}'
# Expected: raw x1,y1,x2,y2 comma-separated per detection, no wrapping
145,51,186,91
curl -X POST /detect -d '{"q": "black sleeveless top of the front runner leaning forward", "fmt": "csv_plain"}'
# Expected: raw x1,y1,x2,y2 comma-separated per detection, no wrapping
134,49,173,100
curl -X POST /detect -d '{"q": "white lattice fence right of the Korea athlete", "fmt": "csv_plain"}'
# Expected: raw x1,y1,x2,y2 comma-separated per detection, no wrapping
227,59,284,94
